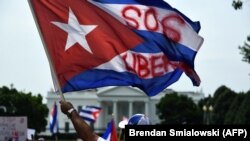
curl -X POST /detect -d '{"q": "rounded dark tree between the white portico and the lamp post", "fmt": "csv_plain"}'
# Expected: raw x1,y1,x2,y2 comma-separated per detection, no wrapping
156,93,202,124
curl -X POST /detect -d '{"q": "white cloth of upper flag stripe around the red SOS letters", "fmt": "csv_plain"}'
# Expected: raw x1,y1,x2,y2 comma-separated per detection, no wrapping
90,1,203,51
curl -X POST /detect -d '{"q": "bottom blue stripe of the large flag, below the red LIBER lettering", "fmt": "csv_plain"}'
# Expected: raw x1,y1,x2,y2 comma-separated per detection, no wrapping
63,69,182,96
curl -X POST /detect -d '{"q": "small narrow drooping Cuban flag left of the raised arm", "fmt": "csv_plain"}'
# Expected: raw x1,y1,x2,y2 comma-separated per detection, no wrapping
49,102,59,134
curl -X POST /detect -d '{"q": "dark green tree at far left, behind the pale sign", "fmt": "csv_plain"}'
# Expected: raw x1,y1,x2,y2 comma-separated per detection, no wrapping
0,86,49,133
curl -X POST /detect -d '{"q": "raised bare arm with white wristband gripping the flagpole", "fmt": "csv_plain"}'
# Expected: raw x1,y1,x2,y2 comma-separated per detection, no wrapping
60,101,99,141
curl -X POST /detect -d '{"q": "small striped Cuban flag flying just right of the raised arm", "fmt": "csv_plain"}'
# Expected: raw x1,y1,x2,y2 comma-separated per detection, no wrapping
79,105,102,123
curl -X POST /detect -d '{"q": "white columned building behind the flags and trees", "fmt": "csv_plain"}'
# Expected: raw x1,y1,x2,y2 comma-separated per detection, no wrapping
45,86,204,134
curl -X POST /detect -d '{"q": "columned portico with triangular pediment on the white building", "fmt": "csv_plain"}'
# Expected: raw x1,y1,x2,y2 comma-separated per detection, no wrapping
97,87,149,126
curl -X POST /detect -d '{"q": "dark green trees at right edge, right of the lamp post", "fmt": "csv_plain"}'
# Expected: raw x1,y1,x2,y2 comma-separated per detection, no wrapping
206,85,250,125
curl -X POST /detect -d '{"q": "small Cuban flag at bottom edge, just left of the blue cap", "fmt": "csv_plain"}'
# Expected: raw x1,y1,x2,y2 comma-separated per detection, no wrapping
102,119,118,141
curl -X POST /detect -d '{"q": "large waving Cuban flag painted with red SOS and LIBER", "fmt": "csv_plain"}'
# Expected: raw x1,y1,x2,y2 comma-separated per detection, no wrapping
30,0,203,96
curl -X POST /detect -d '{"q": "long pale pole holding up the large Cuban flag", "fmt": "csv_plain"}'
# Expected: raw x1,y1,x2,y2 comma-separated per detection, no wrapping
28,0,66,101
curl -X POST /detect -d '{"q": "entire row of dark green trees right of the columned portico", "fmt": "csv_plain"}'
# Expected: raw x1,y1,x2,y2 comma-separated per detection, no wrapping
156,85,250,125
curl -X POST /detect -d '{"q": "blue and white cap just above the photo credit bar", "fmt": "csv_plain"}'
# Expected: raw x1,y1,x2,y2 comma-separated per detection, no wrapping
128,114,151,125
